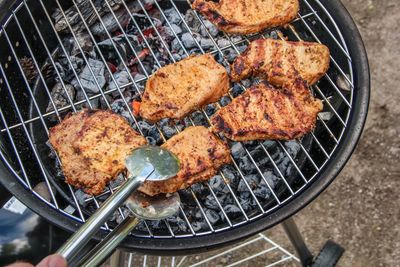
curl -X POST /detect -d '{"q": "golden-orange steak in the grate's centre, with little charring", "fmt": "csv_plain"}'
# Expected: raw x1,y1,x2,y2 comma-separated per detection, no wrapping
140,54,229,122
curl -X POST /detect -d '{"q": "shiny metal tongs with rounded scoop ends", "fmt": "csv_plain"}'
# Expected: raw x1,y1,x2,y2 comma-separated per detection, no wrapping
57,146,180,266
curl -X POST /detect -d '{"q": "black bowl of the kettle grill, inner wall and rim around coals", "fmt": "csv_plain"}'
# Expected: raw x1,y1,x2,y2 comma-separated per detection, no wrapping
0,0,370,255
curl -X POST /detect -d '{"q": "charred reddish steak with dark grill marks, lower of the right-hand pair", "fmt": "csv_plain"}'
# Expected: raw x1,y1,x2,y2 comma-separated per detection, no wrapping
211,78,323,141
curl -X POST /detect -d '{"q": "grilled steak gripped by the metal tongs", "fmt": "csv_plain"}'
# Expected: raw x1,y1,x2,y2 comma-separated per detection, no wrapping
139,126,231,196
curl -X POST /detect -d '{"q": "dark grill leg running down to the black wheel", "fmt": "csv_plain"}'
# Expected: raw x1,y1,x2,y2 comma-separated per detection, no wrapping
282,218,313,267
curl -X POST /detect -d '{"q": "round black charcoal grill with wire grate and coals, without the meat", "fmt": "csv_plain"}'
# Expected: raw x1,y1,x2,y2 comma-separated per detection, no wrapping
0,0,370,262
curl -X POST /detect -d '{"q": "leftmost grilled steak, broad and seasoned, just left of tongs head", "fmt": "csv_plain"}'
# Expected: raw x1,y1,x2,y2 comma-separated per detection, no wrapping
49,110,146,195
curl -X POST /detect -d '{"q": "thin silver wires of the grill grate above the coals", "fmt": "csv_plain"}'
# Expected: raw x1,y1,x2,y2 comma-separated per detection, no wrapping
0,0,354,238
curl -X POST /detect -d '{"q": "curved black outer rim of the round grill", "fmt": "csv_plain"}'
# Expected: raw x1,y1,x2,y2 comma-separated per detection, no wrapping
0,0,370,255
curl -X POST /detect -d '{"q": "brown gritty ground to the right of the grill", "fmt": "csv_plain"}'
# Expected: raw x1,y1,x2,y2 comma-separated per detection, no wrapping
267,0,400,267
